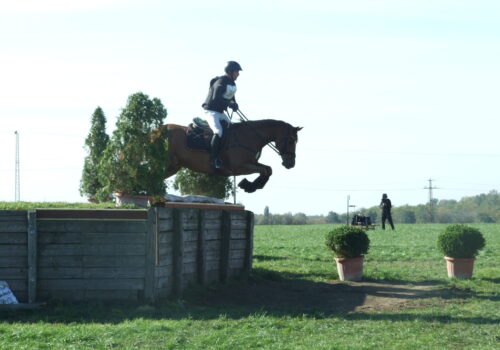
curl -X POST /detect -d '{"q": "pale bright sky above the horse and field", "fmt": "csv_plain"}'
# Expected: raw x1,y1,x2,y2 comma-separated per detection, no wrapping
0,0,500,214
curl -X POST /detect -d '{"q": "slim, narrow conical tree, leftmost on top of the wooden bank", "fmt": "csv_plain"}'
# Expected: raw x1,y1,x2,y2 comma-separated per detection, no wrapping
80,107,111,199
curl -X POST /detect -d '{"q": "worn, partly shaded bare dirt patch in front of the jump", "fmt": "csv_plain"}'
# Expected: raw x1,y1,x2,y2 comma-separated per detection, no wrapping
193,279,466,314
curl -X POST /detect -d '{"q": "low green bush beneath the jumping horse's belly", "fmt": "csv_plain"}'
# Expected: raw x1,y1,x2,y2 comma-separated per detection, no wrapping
174,169,233,199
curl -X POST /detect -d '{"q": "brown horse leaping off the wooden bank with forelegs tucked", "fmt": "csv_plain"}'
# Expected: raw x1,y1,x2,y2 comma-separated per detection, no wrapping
163,120,302,192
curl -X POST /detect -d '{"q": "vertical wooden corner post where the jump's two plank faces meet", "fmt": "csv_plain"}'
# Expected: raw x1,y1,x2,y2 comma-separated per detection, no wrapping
144,208,158,301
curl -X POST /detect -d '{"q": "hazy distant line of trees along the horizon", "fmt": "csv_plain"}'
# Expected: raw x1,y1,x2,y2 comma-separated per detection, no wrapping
255,190,500,225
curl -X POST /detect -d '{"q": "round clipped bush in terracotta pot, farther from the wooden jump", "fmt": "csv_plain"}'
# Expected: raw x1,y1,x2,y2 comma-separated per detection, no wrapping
437,224,485,279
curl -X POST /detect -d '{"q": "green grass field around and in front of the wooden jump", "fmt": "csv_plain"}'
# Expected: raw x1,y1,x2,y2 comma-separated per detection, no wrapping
0,224,500,350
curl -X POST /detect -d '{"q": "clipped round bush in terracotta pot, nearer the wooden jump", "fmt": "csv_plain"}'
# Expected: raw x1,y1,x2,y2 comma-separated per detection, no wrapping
325,225,370,281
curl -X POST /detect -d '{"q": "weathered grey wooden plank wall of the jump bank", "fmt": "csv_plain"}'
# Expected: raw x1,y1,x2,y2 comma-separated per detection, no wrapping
0,207,253,301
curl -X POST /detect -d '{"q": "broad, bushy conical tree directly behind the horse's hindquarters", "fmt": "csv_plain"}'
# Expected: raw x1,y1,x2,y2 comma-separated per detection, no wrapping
99,92,167,200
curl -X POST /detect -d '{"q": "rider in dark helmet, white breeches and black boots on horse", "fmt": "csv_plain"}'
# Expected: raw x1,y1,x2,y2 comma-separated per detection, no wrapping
202,61,242,169
